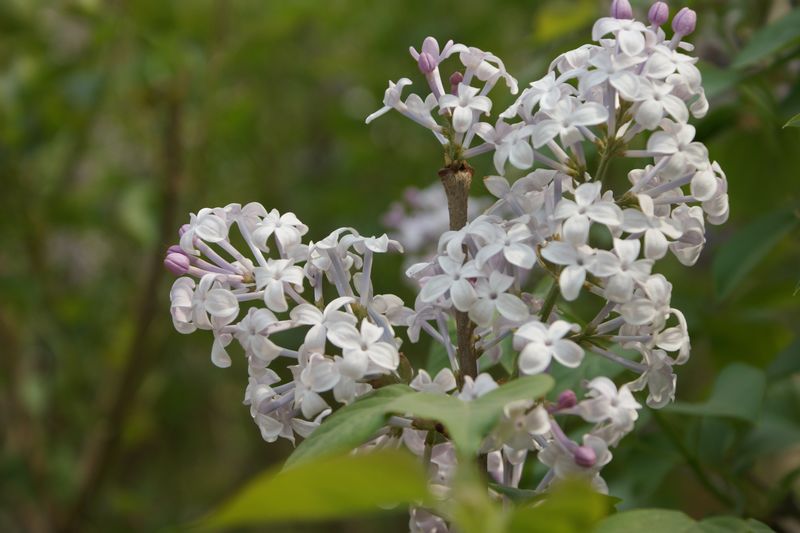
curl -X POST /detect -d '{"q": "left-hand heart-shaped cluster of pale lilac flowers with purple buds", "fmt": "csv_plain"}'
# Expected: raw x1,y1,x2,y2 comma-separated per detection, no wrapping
165,202,411,442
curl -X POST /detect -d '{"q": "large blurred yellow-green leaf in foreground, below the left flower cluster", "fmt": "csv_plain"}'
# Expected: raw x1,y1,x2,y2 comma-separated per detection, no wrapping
198,451,428,530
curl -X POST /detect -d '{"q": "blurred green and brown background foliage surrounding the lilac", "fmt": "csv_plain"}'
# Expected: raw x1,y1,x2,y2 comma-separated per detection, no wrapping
0,0,800,532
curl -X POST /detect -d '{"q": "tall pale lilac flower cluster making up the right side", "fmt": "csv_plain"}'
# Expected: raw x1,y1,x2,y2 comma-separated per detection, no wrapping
368,0,728,520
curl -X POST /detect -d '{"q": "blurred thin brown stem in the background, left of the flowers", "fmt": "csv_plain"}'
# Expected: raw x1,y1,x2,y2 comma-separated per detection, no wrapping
58,89,183,532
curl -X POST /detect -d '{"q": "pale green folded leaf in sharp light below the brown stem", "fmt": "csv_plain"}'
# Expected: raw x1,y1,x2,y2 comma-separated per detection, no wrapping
391,375,553,455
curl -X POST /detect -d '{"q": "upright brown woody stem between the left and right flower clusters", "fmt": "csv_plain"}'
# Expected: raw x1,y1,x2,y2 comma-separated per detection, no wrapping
439,161,478,379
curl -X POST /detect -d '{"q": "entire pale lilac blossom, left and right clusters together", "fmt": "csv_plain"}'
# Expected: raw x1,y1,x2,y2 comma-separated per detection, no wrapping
165,0,729,531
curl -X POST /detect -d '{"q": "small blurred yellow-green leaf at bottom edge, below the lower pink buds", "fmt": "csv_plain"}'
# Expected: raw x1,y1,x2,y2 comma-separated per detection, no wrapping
508,480,616,533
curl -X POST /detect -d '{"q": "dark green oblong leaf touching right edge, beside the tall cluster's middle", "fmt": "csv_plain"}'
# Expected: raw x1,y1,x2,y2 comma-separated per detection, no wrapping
711,209,798,300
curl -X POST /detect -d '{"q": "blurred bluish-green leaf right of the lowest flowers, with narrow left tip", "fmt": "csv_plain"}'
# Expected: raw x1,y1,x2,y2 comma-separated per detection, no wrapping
665,363,767,423
